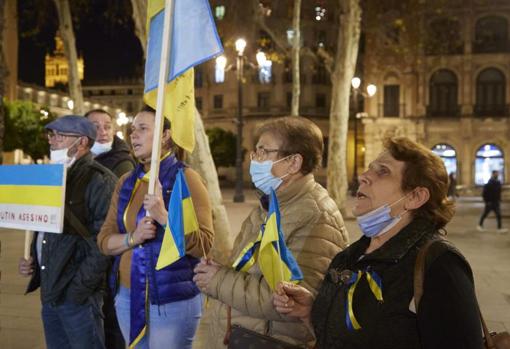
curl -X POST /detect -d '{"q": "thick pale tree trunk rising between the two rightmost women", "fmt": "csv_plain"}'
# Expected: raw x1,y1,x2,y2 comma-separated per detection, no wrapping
328,0,361,212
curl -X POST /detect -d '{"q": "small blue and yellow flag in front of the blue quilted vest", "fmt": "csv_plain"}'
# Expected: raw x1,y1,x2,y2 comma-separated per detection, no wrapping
156,169,199,270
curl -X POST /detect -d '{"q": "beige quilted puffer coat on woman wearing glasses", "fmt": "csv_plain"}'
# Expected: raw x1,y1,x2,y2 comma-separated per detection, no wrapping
204,174,348,348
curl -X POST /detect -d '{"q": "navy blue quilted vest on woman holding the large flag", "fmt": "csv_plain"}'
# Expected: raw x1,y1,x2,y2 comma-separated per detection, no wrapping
110,155,200,305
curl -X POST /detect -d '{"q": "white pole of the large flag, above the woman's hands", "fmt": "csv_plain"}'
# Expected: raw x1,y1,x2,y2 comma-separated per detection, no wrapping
147,0,174,197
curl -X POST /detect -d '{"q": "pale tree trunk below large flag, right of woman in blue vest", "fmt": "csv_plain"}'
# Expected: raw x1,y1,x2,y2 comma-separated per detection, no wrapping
188,110,232,264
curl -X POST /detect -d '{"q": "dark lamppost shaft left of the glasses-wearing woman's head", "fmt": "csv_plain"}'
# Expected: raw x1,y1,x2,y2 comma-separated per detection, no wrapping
234,55,244,202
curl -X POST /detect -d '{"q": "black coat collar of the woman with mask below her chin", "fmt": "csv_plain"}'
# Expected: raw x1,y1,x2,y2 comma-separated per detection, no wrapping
348,217,436,263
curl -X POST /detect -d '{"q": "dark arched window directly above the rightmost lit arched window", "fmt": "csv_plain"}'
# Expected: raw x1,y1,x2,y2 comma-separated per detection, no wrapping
475,68,507,116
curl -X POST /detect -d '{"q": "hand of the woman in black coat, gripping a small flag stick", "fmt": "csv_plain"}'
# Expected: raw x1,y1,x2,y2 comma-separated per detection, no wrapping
273,282,313,323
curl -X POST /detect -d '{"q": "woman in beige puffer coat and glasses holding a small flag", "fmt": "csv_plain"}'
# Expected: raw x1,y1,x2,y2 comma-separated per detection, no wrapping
194,117,347,348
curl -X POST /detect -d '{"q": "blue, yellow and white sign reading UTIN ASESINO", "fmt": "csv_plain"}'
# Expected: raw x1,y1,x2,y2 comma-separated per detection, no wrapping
0,165,65,233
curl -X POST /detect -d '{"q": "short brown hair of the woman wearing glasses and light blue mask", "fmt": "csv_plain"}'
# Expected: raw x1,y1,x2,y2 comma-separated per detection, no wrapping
255,116,324,175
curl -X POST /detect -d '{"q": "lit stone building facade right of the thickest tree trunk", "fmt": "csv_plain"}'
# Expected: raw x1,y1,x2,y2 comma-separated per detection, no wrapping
362,0,510,193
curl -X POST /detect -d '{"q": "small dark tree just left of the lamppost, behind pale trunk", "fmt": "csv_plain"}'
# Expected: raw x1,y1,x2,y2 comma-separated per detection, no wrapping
205,127,236,167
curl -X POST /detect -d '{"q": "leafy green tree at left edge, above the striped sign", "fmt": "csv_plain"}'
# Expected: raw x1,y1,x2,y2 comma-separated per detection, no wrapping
3,101,56,160
